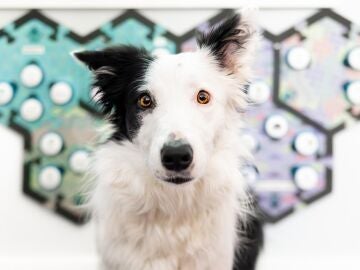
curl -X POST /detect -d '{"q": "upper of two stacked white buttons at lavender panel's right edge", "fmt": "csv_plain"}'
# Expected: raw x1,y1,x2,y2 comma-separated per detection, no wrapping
294,131,319,156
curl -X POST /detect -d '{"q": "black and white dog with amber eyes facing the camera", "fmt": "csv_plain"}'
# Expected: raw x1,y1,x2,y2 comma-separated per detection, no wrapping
75,8,262,270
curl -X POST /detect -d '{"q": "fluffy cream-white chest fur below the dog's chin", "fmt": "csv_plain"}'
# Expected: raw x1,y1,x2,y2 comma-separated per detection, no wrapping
93,142,243,270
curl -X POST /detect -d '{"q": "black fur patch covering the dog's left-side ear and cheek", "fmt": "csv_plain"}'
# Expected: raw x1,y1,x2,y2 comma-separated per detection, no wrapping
75,46,154,140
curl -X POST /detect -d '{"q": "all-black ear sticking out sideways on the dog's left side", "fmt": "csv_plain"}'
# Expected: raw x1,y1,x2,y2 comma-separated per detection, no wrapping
74,46,153,113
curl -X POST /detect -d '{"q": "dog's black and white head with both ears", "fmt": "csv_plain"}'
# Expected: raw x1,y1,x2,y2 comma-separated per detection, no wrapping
75,12,256,184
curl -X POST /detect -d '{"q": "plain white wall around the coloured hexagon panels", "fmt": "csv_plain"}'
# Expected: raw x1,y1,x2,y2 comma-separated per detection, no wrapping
0,1,360,270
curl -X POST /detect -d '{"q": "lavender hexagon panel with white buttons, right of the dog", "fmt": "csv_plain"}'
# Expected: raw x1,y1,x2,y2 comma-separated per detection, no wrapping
243,31,332,222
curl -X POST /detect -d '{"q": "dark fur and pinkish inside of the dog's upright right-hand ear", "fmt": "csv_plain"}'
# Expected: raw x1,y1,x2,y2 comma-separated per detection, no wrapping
197,14,252,67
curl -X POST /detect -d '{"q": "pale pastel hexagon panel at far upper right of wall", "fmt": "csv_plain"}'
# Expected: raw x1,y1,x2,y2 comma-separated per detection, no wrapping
276,9,360,133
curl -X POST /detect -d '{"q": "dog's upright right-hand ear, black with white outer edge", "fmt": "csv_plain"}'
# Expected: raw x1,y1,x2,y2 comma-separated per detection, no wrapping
197,10,259,77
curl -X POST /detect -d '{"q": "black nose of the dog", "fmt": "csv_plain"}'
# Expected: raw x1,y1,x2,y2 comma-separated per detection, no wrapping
161,141,193,172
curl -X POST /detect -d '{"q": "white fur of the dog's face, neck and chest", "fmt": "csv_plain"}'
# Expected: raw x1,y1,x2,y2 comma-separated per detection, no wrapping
92,12,258,270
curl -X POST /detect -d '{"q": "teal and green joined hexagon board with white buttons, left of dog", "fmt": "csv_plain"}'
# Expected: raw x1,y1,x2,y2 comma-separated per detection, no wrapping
0,11,177,223
